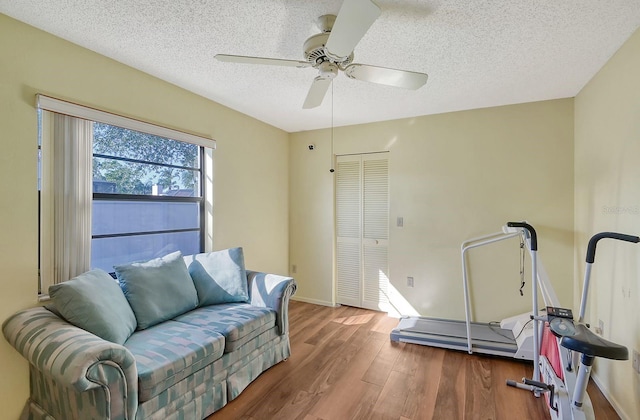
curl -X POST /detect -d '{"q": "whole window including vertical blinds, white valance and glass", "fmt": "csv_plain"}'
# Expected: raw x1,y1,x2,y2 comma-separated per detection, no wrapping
38,96,215,294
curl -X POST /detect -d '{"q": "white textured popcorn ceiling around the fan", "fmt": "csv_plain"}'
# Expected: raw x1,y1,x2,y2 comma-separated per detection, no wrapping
0,0,640,132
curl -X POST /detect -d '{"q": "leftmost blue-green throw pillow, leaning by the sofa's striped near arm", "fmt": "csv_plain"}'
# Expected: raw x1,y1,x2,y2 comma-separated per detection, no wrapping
49,270,136,344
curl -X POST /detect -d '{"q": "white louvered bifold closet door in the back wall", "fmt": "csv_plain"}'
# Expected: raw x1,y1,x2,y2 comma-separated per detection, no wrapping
336,153,389,311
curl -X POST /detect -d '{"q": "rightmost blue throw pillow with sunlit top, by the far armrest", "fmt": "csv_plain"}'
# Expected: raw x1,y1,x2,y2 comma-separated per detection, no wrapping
185,248,249,306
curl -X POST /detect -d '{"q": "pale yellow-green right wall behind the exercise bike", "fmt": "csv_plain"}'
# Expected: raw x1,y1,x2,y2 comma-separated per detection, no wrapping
575,30,640,419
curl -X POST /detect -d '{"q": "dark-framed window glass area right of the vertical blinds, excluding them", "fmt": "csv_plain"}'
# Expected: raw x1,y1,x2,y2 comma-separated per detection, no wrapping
91,123,204,272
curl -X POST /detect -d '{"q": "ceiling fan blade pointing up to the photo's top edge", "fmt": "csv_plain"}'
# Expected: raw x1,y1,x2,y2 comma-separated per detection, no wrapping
325,0,381,58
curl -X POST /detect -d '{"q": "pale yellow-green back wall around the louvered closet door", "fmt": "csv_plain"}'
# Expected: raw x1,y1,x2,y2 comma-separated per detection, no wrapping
290,99,573,321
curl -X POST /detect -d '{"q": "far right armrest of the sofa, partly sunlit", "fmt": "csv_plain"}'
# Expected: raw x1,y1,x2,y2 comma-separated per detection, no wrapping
247,270,297,335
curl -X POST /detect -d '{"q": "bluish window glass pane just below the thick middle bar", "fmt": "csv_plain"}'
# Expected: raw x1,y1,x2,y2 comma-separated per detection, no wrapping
91,200,200,236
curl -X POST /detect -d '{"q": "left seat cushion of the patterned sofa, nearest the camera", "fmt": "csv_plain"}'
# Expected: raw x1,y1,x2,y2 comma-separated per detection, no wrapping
124,321,224,402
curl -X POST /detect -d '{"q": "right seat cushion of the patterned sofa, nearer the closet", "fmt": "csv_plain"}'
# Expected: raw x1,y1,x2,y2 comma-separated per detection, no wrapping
173,303,276,353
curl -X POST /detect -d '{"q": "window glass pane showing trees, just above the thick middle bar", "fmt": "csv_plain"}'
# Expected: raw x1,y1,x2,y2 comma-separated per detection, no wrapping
93,156,200,197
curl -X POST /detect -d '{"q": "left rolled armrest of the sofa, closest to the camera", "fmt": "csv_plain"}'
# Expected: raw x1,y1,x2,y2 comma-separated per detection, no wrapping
2,307,138,418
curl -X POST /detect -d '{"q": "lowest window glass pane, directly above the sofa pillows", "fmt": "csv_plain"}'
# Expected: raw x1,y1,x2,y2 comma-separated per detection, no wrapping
91,231,200,273
